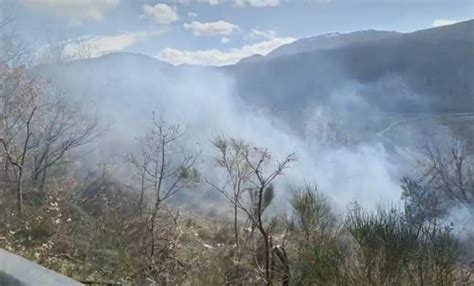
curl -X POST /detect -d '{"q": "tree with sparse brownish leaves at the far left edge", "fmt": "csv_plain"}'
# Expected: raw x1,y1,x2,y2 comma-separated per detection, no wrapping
0,18,36,213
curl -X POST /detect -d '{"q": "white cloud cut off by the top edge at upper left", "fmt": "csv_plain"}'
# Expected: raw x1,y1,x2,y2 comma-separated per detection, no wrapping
20,0,120,23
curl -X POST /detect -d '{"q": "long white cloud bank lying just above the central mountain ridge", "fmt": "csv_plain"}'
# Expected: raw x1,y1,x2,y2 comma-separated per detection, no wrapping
157,37,296,66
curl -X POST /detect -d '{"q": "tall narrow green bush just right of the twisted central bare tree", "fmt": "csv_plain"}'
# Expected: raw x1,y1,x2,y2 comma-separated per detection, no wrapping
289,185,345,285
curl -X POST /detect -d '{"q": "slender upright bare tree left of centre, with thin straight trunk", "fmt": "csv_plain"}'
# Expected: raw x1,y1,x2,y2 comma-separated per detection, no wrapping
132,113,199,270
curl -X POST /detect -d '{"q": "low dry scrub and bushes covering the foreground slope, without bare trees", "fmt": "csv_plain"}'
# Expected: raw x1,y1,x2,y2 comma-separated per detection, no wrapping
0,168,472,285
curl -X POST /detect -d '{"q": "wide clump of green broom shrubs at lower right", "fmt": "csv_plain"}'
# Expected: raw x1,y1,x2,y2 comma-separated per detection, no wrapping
347,206,458,285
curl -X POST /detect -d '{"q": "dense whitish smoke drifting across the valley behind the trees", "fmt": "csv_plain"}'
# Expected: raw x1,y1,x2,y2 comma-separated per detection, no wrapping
39,55,400,209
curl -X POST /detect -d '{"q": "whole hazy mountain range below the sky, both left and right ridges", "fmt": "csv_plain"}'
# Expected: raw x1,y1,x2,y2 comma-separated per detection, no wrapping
36,20,474,134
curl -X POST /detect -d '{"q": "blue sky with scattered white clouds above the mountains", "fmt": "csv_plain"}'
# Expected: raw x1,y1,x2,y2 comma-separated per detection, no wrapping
0,0,474,66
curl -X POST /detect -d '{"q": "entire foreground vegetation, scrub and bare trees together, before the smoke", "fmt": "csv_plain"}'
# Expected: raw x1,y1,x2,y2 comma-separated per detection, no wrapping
0,17,474,286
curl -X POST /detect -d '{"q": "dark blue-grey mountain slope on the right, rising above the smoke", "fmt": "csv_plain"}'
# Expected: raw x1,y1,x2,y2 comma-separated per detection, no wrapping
225,20,474,128
